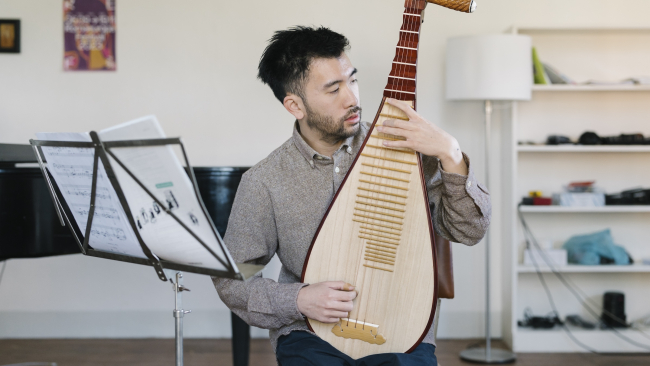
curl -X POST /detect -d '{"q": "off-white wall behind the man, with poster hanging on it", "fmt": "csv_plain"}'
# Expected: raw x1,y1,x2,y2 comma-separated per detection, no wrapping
0,0,650,338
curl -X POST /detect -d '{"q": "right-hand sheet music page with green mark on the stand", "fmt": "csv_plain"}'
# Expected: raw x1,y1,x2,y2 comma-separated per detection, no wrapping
98,116,234,270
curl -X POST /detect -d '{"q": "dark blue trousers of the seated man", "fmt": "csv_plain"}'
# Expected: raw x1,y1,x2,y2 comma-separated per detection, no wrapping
275,331,438,366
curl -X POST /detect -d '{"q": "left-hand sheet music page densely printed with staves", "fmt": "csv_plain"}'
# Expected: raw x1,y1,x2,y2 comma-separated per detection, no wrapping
36,133,146,258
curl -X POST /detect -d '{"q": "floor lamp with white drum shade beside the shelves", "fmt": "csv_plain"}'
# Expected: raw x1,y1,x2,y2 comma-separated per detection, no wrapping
447,34,533,364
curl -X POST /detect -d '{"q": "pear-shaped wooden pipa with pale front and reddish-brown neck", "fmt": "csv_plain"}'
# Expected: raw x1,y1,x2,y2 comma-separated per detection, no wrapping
301,0,475,359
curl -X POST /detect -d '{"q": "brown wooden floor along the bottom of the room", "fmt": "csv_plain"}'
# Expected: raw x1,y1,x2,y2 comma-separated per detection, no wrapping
0,339,650,366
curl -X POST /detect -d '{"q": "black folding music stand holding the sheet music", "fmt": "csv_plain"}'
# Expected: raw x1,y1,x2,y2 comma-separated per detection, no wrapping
29,131,264,366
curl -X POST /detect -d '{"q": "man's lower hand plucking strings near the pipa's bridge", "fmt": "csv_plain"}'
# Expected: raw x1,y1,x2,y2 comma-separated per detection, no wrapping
298,281,357,323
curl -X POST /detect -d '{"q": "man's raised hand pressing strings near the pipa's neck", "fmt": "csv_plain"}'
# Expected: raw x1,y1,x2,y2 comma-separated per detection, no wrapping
377,98,468,175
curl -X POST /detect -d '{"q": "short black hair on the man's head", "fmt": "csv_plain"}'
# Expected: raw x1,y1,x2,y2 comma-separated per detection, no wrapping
257,26,349,103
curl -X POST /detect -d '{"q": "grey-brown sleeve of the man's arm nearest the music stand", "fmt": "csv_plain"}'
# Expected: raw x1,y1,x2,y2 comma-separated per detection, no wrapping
212,172,305,329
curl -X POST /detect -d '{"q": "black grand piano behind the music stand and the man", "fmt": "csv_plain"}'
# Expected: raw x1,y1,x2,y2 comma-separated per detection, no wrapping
0,144,250,366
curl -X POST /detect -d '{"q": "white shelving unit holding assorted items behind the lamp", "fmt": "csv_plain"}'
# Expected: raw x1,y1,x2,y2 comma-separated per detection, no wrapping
502,27,650,352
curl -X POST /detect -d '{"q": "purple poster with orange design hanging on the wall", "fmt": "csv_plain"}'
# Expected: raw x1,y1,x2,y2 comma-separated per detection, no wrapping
63,0,116,71
